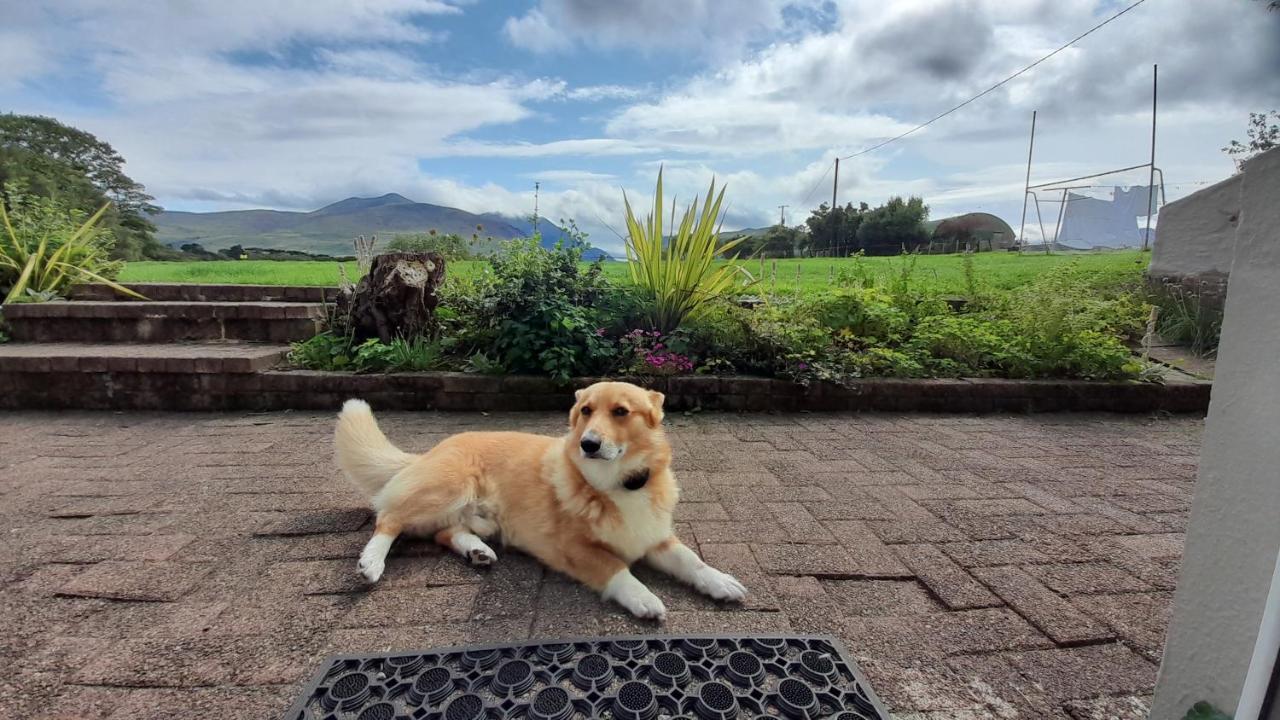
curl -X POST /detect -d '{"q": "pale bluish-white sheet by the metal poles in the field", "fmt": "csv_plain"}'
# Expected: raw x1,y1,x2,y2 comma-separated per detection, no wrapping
1057,184,1156,250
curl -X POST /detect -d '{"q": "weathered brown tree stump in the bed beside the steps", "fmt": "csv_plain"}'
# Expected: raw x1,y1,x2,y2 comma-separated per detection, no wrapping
337,252,444,342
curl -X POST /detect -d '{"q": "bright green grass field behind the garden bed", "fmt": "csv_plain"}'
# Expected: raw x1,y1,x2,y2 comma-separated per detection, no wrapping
119,251,1151,293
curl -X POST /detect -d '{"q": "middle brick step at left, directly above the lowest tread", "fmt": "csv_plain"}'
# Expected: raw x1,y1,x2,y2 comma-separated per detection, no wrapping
4,301,326,343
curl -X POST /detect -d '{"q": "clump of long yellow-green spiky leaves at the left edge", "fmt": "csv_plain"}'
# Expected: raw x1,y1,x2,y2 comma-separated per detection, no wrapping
0,186,142,304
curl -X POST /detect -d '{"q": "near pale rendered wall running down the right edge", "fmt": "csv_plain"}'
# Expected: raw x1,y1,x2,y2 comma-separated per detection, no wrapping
1151,142,1280,720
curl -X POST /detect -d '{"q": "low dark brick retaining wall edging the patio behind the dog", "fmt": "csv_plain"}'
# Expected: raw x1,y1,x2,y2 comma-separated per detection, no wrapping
0,366,1211,413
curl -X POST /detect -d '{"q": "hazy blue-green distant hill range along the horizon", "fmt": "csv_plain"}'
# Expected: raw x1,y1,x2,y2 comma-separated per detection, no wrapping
152,192,608,259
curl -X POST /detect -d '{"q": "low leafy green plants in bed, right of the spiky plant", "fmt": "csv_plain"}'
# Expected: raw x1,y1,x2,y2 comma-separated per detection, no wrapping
689,258,1147,382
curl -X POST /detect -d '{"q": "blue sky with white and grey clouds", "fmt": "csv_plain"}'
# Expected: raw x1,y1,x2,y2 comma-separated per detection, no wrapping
0,0,1280,249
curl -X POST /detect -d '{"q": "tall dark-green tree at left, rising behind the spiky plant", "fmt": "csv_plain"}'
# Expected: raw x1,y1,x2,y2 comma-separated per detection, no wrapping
0,113,166,260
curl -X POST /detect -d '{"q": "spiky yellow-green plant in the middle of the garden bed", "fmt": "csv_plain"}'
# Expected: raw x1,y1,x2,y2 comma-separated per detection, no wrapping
622,169,750,332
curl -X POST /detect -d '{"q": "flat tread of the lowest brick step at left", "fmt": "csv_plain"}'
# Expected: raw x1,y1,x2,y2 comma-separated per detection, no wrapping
0,342,289,374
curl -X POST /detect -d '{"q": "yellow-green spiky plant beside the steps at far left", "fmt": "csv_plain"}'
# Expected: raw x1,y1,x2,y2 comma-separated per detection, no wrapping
0,192,146,305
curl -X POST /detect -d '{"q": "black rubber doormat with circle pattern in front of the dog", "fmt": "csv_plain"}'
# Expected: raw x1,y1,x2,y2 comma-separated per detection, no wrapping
285,635,888,720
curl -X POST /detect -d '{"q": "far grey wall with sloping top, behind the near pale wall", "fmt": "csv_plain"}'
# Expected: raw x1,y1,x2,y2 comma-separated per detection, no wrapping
1149,174,1244,279
